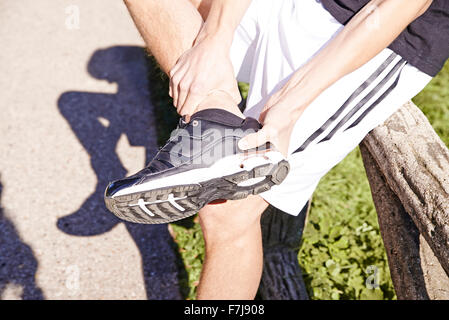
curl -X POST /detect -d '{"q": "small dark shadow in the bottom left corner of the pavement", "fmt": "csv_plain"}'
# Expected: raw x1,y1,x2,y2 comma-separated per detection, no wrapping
0,178,44,300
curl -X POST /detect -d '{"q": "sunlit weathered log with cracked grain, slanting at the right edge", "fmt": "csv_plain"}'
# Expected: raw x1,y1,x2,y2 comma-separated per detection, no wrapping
361,102,449,273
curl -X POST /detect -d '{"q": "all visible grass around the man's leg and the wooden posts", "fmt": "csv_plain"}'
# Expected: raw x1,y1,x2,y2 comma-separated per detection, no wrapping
150,55,449,300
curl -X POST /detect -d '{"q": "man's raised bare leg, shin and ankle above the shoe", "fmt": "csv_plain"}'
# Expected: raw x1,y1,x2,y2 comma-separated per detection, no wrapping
124,0,244,117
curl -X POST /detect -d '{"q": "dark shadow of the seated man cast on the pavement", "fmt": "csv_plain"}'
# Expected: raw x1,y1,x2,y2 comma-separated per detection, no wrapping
57,46,184,299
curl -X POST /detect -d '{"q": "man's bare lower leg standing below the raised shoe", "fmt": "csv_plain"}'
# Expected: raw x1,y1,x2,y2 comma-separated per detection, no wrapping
197,196,268,300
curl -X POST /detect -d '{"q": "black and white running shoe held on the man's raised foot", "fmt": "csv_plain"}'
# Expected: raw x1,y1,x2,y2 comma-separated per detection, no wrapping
104,109,289,224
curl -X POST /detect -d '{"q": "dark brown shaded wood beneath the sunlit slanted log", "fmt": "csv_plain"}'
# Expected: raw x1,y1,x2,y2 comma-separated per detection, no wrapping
360,144,449,300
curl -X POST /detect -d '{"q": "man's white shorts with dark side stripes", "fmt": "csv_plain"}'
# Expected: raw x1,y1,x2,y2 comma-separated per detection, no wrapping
231,0,431,215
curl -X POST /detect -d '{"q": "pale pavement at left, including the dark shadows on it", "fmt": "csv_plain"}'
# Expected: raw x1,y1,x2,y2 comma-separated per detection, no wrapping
0,0,182,299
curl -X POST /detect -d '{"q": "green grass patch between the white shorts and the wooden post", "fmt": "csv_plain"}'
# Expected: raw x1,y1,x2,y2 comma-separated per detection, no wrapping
298,148,395,300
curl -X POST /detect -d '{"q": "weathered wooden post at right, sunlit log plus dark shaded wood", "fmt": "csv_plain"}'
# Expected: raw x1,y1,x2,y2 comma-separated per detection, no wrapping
360,102,449,300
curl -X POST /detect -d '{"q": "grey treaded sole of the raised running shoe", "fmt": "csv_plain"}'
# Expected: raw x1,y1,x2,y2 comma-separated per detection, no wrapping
105,160,290,224
